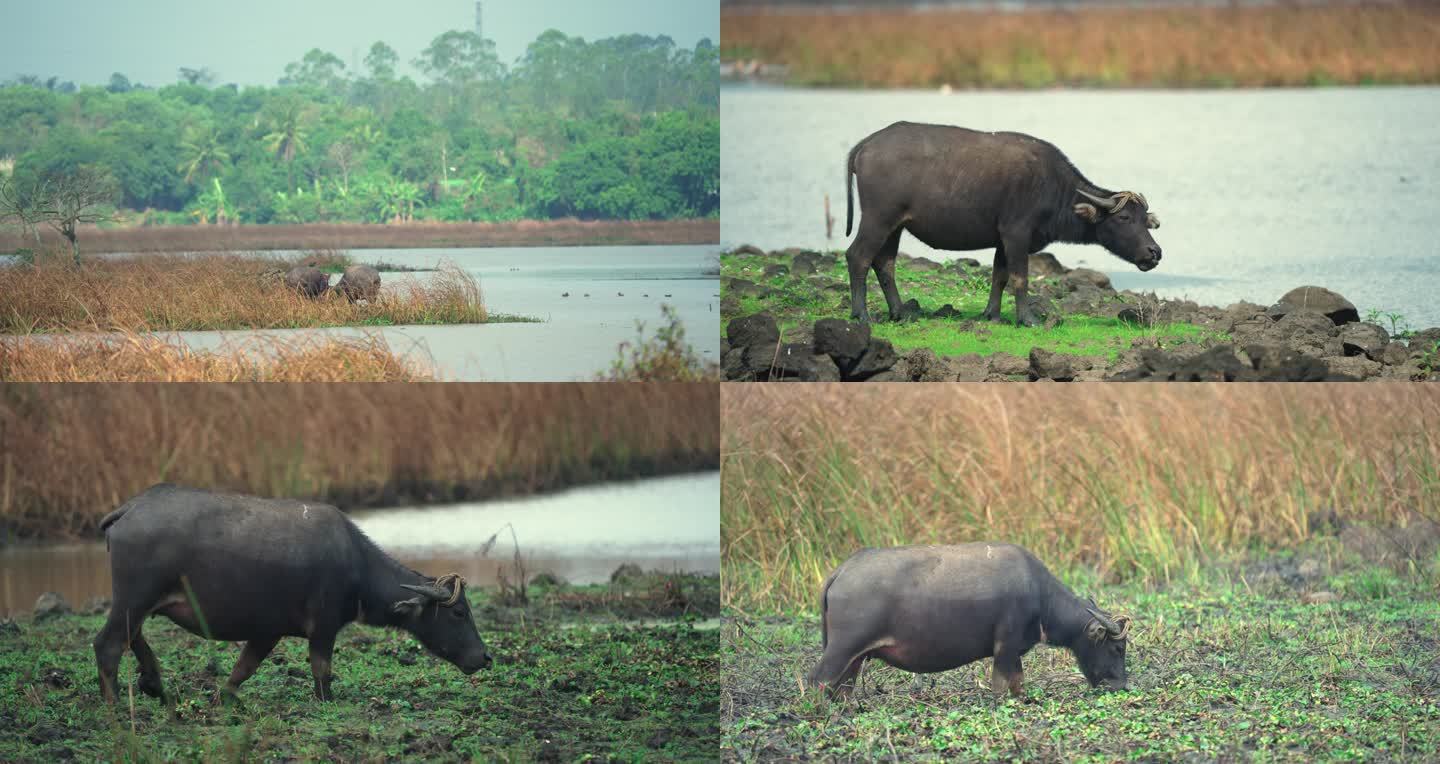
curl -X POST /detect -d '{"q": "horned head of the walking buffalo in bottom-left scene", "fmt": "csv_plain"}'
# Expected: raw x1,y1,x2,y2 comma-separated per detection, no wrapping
395,573,491,673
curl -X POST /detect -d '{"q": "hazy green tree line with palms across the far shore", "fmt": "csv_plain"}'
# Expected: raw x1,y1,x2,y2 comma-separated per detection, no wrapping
0,30,720,224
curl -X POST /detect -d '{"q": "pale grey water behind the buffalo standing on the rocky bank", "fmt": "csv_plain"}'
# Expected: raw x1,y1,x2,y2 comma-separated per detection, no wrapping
720,86,1440,328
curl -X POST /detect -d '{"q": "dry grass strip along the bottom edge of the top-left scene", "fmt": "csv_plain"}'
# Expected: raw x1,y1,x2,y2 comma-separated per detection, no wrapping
0,332,435,383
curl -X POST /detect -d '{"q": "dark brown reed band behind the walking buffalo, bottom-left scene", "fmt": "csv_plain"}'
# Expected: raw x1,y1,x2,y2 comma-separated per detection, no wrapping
0,383,720,538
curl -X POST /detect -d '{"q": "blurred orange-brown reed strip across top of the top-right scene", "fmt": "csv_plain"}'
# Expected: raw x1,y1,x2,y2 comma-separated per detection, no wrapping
720,1,1440,88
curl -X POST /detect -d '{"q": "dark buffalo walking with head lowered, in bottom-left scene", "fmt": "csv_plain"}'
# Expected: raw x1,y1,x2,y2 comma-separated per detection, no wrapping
95,485,491,702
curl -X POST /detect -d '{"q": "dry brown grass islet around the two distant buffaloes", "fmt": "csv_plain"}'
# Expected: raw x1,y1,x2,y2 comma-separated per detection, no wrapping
0,255,488,334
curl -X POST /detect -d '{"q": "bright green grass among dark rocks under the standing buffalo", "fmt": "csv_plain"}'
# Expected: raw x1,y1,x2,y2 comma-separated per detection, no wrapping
720,252,1220,360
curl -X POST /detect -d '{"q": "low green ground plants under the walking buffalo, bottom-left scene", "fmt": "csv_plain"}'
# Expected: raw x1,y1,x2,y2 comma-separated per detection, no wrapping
0,576,719,761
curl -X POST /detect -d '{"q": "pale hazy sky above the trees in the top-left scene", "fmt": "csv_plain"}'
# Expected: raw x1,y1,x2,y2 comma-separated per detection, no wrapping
0,0,720,85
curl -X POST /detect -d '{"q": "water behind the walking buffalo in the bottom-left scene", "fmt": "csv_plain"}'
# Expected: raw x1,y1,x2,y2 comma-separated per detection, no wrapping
0,473,720,616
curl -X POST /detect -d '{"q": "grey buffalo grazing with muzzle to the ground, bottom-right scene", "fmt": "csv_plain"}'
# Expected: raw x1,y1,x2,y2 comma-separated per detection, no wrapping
809,542,1130,695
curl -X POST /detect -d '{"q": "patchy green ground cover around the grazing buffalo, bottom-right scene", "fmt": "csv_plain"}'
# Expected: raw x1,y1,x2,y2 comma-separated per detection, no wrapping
720,565,1440,761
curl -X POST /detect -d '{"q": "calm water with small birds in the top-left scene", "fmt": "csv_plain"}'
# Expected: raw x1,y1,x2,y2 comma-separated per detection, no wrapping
144,245,720,381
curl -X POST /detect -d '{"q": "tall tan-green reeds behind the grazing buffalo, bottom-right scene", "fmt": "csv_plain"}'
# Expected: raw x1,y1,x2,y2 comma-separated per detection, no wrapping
720,384,1440,610
